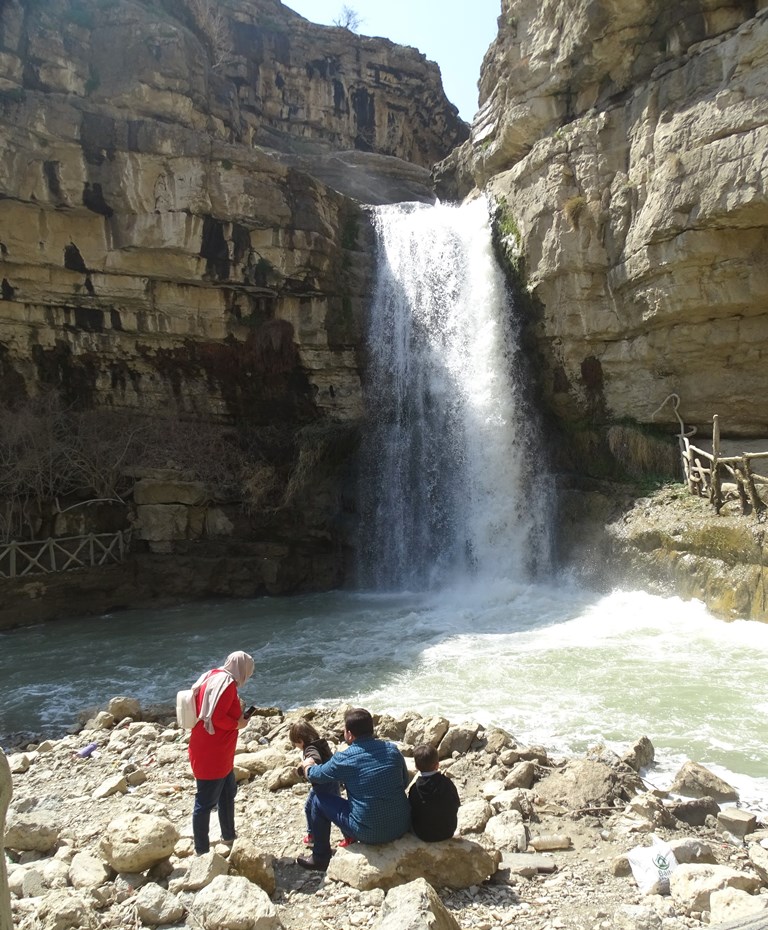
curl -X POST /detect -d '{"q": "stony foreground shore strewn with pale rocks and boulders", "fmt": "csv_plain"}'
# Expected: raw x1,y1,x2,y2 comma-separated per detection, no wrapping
0,698,768,930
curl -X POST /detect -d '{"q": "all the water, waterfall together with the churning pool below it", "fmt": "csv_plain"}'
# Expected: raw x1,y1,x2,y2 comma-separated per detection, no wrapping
0,201,768,810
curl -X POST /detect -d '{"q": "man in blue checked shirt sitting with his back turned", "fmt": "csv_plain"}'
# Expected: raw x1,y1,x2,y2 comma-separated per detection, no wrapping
296,708,411,872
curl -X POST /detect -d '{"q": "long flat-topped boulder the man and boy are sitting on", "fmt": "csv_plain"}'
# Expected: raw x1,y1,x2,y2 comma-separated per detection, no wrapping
327,833,498,891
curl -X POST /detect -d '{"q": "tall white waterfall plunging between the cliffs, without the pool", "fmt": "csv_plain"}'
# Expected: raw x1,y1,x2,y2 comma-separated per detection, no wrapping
359,199,549,590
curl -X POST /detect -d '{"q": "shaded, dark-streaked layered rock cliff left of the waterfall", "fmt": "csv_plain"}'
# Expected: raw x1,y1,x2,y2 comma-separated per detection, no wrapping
0,0,467,624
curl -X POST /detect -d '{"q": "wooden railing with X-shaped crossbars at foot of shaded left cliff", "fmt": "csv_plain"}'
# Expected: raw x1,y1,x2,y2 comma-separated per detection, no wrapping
0,530,131,578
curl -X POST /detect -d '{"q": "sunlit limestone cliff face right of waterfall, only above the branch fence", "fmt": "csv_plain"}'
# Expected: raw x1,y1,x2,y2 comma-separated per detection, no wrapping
439,0,768,437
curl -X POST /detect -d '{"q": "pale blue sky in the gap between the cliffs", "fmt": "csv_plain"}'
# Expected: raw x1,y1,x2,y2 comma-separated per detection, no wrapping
283,0,501,123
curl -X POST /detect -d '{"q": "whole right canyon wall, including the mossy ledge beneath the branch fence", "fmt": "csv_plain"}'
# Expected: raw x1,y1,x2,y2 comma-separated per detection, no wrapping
436,0,768,620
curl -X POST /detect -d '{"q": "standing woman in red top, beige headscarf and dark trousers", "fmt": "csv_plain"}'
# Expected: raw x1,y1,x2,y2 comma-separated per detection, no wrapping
189,652,253,855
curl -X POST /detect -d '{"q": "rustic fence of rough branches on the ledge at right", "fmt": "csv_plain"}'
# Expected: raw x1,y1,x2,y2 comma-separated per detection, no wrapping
678,414,768,520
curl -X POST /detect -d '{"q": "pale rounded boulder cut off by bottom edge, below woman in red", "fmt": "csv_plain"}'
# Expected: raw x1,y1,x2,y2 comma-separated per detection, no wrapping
190,875,282,930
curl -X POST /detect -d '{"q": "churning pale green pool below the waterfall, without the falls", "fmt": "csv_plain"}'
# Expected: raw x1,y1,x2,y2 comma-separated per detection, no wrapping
0,583,768,805
